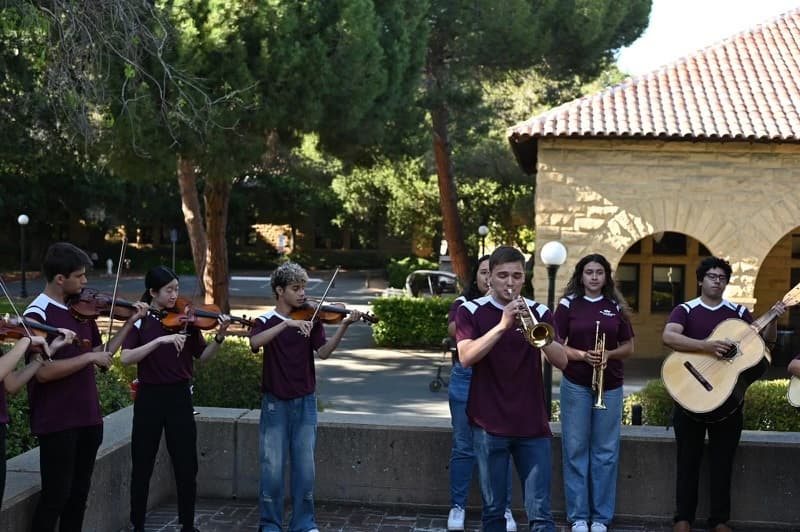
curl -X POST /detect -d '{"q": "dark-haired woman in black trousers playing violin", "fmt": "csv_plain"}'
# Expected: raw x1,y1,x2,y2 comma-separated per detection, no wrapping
121,266,230,532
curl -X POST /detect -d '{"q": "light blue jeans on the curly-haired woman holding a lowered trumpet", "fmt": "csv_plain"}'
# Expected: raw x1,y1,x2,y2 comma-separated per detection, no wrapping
561,377,622,525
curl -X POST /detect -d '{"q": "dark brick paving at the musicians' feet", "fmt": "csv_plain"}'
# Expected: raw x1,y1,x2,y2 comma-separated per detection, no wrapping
130,499,688,532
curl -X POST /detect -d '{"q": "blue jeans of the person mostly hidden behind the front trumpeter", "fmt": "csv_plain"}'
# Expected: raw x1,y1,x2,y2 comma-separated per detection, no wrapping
447,362,513,508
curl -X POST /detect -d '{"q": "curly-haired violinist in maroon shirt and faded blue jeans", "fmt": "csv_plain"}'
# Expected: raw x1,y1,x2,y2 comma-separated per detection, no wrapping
250,262,361,532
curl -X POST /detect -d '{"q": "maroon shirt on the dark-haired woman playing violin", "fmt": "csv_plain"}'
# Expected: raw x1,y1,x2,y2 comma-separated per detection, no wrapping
122,314,206,384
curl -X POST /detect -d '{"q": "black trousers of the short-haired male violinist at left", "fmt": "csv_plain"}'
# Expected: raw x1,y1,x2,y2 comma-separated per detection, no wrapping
32,425,103,532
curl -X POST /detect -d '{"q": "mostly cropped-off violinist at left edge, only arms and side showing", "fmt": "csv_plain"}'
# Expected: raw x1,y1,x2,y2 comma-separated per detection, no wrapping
0,329,75,508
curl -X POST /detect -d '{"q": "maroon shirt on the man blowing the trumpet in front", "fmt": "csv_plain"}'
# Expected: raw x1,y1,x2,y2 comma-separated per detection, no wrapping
456,296,553,438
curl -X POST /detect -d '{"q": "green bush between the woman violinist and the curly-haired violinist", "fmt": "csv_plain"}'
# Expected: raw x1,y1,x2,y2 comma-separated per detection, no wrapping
192,336,261,409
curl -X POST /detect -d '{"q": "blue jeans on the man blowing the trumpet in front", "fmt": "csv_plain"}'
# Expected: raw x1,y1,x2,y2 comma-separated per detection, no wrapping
472,426,555,532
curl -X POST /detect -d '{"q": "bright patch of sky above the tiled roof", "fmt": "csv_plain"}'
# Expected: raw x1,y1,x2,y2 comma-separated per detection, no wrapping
617,0,800,76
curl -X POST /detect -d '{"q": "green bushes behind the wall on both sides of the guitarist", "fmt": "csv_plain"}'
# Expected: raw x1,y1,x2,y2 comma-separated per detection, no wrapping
622,379,800,432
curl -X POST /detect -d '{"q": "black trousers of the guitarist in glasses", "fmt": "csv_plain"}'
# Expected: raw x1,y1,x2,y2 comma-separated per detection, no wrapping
673,405,743,528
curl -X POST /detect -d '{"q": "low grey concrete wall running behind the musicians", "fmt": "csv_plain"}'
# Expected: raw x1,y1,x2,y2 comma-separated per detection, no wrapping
0,407,800,532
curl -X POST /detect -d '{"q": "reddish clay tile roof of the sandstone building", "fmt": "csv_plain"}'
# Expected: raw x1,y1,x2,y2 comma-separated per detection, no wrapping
508,8,800,143
